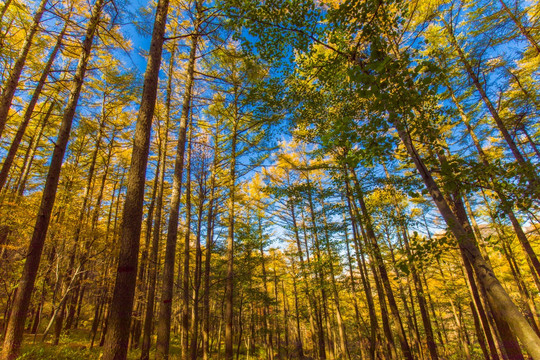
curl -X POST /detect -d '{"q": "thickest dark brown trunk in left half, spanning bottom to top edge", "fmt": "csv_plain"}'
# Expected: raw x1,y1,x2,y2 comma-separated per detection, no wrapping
103,0,169,360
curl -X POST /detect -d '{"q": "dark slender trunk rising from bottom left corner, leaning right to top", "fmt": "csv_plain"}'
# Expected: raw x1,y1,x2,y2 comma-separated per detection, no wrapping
1,0,105,360
